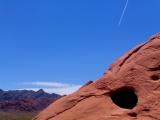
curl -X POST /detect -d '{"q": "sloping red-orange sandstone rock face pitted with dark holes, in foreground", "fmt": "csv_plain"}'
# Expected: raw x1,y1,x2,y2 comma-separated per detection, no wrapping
33,34,160,120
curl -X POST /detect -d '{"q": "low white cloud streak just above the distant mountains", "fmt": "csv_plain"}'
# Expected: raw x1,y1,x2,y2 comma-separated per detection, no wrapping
20,82,82,95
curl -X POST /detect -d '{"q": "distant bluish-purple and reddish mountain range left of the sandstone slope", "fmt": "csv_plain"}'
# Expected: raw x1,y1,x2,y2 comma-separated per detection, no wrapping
0,89,61,112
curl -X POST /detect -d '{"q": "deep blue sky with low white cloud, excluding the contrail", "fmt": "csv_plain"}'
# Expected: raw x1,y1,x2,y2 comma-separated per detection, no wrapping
0,0,160,94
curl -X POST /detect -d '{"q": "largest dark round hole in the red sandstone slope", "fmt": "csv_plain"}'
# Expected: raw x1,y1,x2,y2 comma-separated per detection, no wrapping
111,87,138,109
